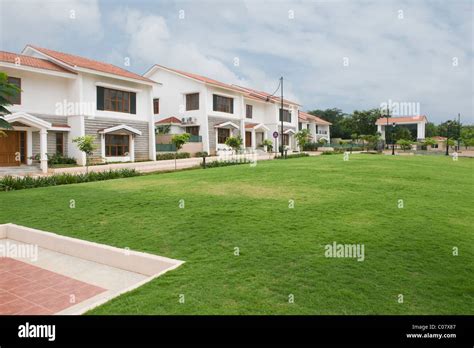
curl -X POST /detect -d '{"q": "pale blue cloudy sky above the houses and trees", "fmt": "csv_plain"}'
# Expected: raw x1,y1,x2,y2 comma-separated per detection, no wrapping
0,0,474,123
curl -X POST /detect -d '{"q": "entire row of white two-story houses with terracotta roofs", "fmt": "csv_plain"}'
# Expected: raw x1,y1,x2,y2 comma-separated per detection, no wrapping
0,45,330,171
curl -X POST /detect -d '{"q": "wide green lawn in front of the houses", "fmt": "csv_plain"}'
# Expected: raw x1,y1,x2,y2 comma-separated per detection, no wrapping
0,155,474,314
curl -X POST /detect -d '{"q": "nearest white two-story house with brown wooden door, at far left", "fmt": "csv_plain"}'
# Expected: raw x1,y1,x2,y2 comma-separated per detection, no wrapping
0,45,156,172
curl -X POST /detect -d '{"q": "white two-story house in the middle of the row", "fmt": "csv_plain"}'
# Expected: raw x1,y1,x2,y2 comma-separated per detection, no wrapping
143,65,299,154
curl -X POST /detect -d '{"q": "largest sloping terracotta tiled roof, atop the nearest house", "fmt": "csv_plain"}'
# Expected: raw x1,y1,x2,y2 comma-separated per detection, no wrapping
27,45,154,82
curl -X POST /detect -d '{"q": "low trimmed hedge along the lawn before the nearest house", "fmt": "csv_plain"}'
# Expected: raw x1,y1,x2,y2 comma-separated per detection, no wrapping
0,169,140,191
